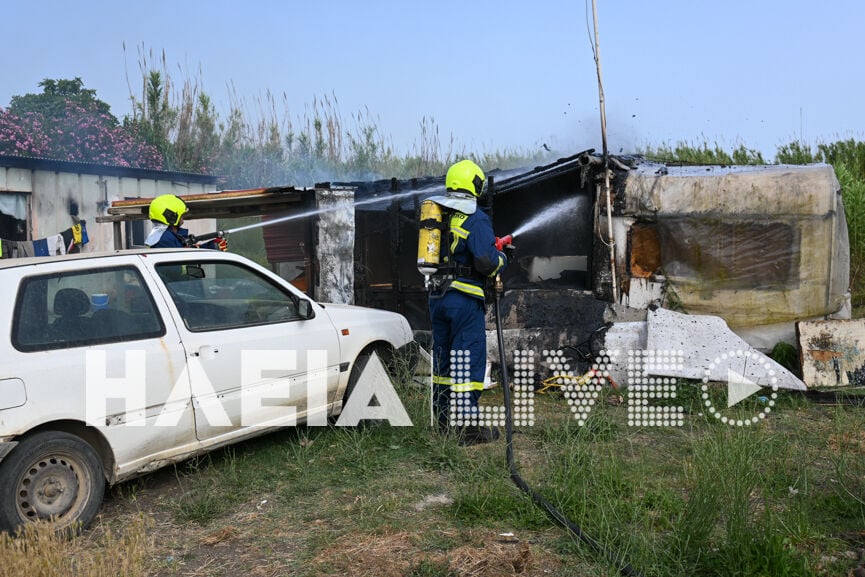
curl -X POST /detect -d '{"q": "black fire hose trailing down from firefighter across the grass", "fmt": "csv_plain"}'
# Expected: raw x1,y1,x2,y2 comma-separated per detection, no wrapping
494,281,642,577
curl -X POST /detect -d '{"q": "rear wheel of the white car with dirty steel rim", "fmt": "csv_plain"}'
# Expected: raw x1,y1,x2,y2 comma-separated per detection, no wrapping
0,431,105,533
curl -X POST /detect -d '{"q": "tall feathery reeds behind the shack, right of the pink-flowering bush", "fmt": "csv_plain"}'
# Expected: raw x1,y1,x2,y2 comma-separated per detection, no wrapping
125,47,544,188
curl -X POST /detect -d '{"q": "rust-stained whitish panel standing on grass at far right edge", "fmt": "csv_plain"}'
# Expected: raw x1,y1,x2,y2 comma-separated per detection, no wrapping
796,319,865,387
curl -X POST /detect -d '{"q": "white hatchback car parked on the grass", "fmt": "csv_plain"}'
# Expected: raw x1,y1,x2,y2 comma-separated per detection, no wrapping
0,249,413,532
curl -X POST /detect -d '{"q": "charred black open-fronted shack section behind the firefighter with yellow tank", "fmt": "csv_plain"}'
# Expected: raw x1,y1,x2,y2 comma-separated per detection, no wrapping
340,151,608,350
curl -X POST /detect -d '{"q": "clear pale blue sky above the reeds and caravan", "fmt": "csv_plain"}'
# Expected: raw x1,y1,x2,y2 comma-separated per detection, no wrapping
0,0,865,161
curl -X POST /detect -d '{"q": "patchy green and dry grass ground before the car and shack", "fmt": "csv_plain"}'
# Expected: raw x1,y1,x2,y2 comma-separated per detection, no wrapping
23,356,865,577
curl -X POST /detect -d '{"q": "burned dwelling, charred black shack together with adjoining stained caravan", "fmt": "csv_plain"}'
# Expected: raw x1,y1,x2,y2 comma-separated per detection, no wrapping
333,150,849,372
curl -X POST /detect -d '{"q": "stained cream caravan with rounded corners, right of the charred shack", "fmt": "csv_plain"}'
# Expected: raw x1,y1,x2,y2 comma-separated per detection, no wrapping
598,159,850,350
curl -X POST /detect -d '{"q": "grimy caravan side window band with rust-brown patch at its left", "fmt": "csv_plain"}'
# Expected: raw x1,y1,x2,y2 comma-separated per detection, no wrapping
630,217,800,290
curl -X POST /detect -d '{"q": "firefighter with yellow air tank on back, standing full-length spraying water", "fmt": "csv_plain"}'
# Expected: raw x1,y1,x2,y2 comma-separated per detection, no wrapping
429,160,508,445
